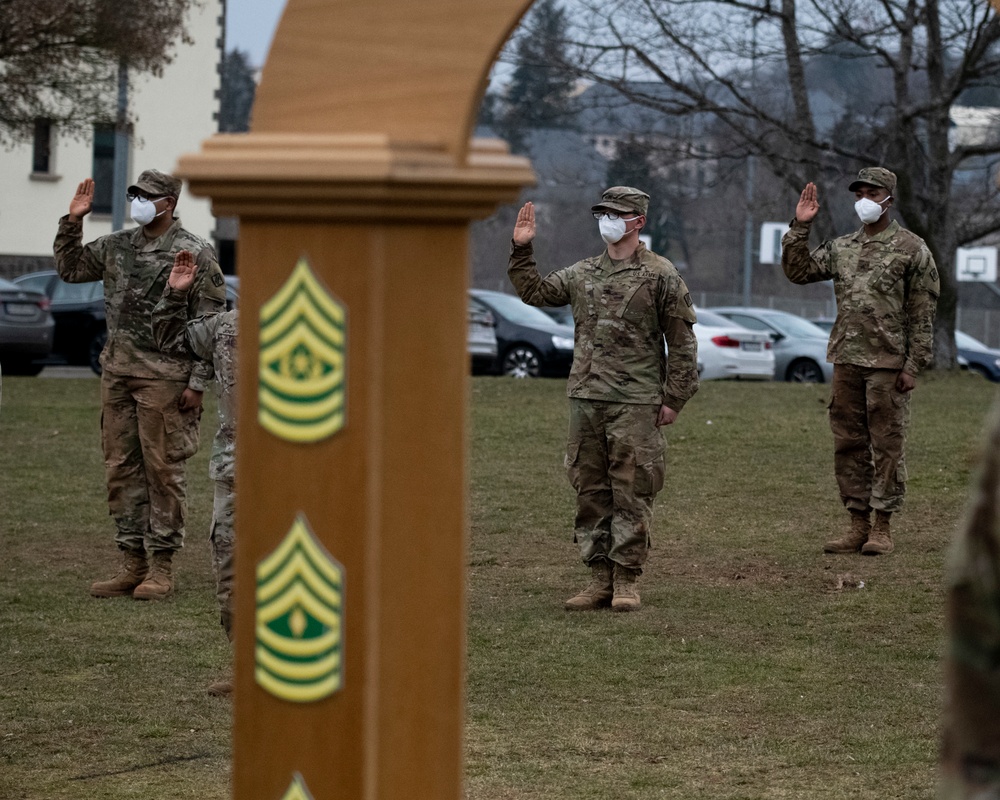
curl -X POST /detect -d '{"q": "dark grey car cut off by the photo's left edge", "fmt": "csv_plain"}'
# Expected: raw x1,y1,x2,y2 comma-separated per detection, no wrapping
0,278,55,375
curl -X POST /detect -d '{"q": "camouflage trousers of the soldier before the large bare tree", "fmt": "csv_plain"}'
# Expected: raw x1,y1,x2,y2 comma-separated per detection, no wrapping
830,364,910,511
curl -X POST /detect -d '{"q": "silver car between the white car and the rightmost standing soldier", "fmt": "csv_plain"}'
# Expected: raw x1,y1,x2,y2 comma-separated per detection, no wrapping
709,306,833,383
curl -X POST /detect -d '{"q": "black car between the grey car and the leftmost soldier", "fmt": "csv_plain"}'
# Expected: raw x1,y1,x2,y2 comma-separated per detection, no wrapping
13,270,108,374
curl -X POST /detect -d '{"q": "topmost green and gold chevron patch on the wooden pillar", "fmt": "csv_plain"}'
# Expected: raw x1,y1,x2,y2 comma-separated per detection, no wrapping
257,258,347,442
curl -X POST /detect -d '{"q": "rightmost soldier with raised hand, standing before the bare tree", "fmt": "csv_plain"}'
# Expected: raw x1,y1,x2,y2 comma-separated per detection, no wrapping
781,167,940,555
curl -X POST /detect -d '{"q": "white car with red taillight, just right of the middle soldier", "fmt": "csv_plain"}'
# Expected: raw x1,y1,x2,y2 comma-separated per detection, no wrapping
694,309,774,381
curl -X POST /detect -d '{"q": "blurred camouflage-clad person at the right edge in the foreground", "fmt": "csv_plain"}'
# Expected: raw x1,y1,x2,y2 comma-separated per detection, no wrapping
939,405,1000,800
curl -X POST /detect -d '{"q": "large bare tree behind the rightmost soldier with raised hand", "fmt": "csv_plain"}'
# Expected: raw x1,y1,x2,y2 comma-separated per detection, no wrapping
565,0,1000,366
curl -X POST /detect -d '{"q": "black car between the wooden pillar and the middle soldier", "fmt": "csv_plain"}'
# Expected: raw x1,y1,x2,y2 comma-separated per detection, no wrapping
469,289,573,378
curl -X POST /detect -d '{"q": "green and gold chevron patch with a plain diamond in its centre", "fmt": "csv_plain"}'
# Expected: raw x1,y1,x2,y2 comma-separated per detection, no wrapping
255,516,344,703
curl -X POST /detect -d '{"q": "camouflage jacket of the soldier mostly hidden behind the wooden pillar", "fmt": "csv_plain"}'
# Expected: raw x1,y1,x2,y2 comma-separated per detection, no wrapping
152,286,239,481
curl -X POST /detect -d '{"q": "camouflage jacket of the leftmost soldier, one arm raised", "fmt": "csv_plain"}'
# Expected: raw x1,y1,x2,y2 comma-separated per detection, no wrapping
53,216,226,392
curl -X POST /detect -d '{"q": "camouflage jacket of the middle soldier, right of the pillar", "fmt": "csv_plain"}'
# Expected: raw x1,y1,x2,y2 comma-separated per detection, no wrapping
507,243,698,411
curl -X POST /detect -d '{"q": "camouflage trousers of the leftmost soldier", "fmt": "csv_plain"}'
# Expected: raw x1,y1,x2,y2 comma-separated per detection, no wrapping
101,370,201,552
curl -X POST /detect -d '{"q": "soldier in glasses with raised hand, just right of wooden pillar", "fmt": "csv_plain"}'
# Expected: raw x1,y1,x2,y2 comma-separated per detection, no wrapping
507,186,698,611
